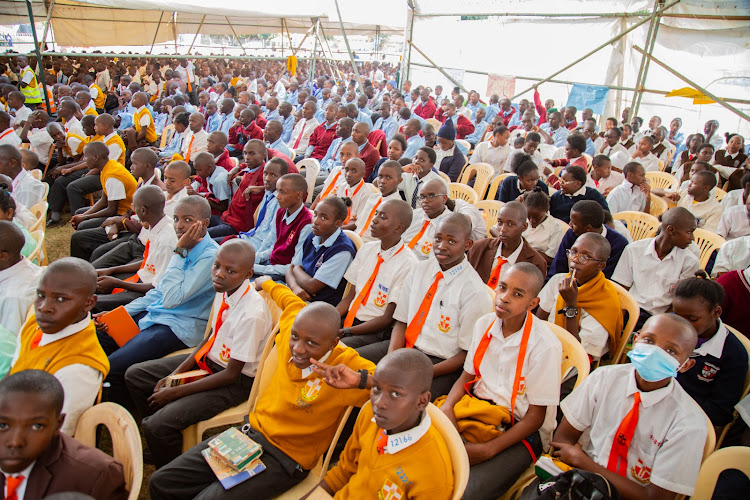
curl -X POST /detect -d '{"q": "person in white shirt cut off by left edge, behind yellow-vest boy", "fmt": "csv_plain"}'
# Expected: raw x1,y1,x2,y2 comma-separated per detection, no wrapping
0,221,42,335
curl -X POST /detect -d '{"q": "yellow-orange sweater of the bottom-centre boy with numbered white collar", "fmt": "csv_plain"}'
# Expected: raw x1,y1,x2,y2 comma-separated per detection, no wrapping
325,405,453,500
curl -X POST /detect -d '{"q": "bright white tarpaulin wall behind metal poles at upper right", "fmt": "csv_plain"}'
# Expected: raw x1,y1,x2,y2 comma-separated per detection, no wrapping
405,0,750,137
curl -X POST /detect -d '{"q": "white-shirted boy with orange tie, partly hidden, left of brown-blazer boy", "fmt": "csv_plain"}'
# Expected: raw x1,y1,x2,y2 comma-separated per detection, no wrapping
404,179,487,260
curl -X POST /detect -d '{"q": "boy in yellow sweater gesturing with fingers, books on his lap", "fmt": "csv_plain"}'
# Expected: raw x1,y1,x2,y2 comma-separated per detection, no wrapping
149,277,375,500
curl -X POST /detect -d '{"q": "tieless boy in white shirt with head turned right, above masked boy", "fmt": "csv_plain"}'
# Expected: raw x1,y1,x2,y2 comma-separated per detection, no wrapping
612,207,700,328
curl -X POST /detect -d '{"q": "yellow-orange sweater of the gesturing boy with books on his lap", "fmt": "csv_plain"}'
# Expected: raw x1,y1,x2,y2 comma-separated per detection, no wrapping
248,281,375,469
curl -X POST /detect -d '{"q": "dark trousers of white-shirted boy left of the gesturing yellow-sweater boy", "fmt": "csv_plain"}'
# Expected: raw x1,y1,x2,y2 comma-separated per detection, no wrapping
125,354,253,468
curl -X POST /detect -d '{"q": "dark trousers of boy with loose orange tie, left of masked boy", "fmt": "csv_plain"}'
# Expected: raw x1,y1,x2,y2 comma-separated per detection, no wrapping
463,432,542,500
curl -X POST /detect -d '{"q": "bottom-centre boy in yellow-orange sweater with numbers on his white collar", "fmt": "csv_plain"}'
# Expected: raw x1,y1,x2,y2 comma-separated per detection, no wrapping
306,349,453,500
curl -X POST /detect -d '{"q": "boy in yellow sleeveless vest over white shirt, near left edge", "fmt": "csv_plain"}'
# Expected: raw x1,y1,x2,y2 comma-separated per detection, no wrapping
10,257,109,436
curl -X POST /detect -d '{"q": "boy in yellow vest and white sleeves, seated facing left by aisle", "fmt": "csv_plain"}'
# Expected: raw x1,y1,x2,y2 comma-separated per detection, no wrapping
70,141,138,229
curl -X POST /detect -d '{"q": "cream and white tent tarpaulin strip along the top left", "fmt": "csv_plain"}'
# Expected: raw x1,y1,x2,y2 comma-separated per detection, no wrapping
0,0,406,47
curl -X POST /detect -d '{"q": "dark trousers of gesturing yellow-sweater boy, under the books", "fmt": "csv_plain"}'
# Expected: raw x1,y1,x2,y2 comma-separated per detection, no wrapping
149,422,313,500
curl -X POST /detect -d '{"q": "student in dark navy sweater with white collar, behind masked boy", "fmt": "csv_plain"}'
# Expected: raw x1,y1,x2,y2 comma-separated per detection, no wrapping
672,278,748,426
